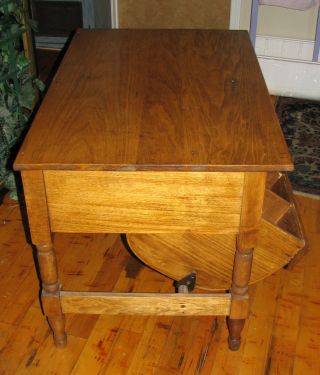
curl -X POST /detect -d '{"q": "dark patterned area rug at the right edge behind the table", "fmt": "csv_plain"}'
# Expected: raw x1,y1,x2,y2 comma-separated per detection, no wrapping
276,97,320,197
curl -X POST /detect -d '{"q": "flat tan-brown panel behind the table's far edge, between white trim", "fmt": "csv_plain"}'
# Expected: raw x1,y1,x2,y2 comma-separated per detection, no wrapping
118,0,230,29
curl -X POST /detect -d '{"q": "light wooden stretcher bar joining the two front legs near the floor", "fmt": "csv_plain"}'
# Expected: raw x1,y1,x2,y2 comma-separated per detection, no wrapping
61,291,231,316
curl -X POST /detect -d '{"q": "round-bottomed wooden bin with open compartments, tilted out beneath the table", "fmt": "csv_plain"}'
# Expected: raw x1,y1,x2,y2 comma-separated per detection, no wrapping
127,175,306,290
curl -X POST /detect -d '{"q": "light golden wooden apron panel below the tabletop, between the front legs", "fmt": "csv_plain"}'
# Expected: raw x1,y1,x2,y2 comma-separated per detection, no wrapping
44,171,244,233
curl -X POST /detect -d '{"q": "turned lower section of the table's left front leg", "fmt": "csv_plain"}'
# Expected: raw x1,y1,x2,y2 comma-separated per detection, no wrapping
37,244,67,347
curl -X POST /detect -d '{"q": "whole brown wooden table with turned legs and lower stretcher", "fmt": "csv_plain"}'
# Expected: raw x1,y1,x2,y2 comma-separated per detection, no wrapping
15,30,301,349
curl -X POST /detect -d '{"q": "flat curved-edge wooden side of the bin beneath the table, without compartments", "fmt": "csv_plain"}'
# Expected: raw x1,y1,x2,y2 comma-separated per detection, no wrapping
127,216,304,291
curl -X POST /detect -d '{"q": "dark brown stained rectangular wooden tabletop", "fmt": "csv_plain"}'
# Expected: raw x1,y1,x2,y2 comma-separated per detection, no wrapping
15,30,293,171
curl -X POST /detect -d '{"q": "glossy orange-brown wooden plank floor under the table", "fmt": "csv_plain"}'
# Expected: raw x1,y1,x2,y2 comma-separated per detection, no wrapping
0,197,320,375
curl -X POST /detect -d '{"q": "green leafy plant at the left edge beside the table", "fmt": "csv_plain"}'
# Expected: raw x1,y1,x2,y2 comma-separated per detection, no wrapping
0,0,44,199
